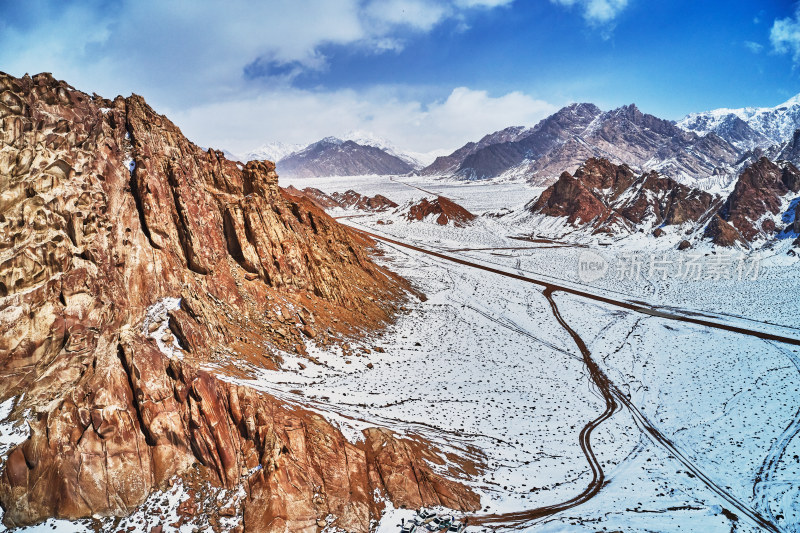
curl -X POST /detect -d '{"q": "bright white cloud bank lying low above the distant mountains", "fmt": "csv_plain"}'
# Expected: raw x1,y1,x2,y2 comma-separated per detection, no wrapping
169,87,556,153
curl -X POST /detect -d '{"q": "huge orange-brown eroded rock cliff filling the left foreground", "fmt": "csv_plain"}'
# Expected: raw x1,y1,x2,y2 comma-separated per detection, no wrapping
0,74,479,531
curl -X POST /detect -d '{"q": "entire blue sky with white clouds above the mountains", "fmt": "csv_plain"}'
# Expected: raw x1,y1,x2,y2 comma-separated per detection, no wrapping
0,0,800,152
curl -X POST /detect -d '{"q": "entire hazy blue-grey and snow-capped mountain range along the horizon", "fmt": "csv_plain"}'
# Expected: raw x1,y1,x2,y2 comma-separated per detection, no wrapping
241,96,800,189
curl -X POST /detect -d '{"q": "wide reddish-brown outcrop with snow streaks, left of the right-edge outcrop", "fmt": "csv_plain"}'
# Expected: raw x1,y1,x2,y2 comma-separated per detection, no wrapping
526,159,721,234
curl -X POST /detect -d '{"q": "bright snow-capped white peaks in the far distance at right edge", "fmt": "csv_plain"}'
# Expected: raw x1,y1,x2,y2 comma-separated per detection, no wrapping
677,95,800,150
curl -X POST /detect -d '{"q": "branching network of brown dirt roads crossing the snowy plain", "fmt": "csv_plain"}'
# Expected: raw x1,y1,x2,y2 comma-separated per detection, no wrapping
349,226,800,533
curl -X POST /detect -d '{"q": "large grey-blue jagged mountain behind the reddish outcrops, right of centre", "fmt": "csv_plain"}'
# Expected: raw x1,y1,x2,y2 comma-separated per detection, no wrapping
421,103,742,184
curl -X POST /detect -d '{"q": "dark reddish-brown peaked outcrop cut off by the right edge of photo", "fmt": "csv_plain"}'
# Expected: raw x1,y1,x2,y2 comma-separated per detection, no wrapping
709,157,800,246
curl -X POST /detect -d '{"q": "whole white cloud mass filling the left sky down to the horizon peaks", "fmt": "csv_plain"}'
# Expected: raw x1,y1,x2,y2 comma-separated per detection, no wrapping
0,0,553,152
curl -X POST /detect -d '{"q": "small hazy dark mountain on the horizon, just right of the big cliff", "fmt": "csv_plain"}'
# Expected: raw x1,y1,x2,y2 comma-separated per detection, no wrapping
278,137,414,178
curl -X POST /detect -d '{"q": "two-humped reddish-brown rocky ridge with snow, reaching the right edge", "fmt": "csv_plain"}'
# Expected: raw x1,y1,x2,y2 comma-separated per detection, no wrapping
526,157,800,246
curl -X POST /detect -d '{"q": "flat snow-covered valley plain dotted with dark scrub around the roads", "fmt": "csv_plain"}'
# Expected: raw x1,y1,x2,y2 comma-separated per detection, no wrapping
270,172,800,532
